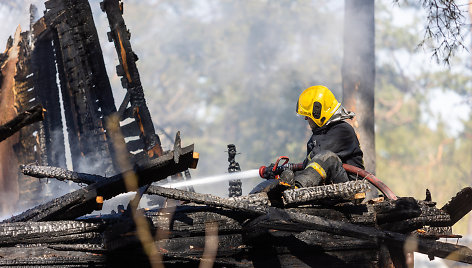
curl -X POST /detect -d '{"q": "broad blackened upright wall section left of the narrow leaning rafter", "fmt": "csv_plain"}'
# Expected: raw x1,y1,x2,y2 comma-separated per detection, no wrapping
44,0,116,175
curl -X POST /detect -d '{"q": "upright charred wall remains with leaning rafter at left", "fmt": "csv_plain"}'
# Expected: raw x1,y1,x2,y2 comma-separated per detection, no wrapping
0,0,170,209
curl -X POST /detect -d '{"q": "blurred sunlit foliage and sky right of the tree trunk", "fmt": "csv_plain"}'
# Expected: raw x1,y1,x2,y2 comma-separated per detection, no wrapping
375,1,472,234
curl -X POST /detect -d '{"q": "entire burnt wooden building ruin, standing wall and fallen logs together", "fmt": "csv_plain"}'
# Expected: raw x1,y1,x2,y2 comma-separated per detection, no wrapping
0,0,472,267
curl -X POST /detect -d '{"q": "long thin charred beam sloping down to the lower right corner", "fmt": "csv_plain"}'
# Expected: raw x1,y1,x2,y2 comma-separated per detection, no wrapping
148,186,472,263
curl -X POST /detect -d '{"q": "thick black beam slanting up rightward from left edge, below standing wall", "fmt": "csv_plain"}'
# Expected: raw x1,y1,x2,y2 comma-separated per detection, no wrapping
4,145,195,222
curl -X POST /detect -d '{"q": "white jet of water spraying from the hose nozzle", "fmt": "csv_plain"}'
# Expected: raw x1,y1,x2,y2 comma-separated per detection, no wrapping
161,169,259,188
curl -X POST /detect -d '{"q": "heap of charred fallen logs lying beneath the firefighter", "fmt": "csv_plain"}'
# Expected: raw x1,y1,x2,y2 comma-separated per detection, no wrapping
0,159,472,267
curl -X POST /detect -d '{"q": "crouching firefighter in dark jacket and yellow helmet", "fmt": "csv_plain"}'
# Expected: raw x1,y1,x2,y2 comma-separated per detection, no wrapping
294,85,364,187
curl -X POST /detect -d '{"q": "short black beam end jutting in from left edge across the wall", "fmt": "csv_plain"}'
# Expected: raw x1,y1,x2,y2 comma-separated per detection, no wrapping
0,105,44,142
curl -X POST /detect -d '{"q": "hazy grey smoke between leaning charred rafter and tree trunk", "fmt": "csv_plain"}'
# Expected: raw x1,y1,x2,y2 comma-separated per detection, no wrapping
86,0,342,196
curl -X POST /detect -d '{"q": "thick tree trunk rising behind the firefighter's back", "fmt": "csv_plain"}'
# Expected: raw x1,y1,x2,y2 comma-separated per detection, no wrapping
342,0,375,174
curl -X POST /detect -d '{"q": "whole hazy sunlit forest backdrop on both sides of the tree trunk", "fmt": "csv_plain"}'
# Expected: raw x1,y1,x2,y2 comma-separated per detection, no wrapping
0,0,472,266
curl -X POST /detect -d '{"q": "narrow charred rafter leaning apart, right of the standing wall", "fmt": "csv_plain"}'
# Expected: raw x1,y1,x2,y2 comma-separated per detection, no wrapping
100,0,162,157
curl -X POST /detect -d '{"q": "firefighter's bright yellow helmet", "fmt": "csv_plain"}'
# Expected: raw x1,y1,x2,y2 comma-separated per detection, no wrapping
297,86,341,127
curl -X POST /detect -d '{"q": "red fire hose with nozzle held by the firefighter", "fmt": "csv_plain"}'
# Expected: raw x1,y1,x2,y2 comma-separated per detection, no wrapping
259,156,398,200
